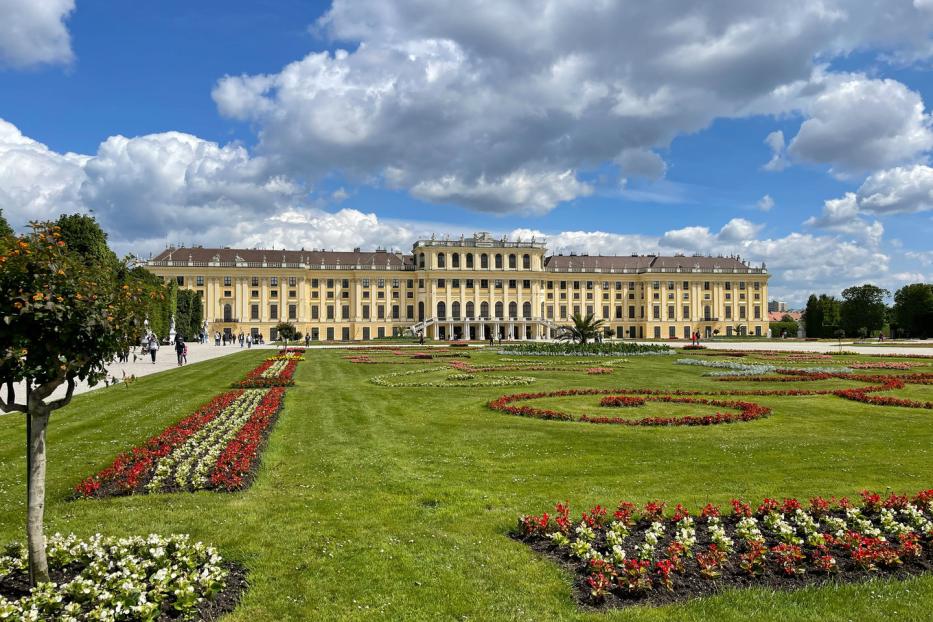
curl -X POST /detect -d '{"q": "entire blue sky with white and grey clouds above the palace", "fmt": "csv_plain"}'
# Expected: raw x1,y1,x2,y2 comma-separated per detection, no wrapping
0,0,933,306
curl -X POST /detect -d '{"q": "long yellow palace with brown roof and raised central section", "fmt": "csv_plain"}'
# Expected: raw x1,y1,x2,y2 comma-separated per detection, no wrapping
143,233,769,341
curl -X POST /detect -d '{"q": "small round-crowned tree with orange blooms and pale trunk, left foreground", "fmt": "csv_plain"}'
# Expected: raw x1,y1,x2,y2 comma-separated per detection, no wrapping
0,223,155,585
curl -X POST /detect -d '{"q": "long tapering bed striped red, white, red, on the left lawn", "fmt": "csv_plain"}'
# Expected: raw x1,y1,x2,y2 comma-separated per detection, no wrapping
75,387,285,497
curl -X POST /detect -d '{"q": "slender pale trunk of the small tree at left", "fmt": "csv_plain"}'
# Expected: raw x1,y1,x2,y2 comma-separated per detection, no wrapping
26,402,51,585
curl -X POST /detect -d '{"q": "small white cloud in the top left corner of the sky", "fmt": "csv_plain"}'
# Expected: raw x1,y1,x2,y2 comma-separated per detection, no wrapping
0,0,75,69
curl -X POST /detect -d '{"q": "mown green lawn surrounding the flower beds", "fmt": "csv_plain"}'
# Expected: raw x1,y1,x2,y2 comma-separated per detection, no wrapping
0,351,933,622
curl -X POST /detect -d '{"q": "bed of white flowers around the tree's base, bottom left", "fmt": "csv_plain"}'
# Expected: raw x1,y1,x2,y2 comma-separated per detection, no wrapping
0,534,246,622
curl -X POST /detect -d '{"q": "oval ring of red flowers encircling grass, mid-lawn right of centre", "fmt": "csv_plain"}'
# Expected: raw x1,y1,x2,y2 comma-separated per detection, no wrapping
487,389,771,426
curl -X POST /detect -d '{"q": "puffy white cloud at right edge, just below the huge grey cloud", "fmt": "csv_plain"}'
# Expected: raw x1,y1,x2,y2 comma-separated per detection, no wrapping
788,76,933,176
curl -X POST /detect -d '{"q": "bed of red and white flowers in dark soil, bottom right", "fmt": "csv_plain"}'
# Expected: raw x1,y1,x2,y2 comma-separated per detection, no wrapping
514,490,933,608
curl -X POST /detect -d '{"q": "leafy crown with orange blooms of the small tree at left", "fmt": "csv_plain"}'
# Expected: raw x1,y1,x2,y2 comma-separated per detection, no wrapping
0,223,159,394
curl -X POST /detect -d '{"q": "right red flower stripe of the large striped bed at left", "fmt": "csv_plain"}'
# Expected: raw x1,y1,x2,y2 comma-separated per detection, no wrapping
211,387,285,490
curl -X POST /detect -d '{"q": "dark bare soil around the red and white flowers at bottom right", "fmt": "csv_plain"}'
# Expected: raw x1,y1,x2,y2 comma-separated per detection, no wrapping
510,516,933,610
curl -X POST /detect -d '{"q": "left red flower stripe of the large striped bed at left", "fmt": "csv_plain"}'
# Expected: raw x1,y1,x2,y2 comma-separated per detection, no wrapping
75,391,243,497
